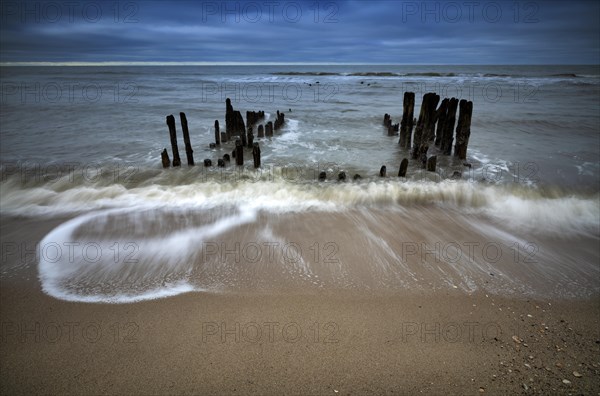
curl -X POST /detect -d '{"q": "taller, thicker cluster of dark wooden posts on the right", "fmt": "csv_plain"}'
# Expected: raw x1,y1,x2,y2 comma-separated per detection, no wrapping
379,92,473,177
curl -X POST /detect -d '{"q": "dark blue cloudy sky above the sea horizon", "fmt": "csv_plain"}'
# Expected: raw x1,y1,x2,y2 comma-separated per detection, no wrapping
0,0,600,64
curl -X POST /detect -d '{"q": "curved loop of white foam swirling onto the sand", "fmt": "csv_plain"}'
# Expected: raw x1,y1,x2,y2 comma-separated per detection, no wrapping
38,207,257,303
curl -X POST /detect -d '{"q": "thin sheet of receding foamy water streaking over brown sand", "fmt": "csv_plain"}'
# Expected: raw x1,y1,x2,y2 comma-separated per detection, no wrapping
39,190,600,303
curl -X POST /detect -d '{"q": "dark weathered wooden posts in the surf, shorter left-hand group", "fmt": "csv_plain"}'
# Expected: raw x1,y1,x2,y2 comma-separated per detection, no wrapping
161,98,285,168
